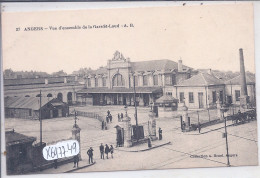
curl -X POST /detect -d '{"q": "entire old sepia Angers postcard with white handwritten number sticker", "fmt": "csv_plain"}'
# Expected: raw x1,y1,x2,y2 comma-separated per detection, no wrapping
2,3,258,175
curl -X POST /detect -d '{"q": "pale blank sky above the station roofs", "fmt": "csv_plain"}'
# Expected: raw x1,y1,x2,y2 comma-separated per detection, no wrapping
2,3,255,74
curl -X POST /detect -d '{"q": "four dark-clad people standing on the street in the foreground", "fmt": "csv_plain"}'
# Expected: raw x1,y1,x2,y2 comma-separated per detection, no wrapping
87,143,114,164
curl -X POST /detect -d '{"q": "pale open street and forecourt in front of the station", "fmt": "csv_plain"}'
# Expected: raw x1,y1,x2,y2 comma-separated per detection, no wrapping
5,106,258,173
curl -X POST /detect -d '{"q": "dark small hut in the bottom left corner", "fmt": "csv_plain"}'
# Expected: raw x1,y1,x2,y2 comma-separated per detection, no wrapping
5,130,36,174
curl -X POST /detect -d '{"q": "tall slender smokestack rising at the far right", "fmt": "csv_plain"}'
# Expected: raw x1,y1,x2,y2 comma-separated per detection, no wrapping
239,48,248,106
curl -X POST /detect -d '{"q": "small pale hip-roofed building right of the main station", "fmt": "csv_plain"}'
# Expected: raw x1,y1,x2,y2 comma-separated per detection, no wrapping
173,72,225,109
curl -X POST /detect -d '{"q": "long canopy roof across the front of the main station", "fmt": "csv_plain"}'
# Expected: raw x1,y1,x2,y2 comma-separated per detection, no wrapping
77,87,162,94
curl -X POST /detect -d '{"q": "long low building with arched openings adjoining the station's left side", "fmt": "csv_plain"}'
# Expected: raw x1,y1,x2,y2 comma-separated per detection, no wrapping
4,76,84,105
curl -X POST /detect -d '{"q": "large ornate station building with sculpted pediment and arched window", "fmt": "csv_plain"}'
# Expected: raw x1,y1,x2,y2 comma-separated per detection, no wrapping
77,51,195,106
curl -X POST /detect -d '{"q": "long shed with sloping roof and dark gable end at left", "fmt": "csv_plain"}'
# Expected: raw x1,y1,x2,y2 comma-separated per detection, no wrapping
4,97,69,119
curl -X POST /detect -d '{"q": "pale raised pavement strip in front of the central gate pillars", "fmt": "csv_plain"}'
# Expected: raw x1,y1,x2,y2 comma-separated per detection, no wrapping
115,140,171,152
